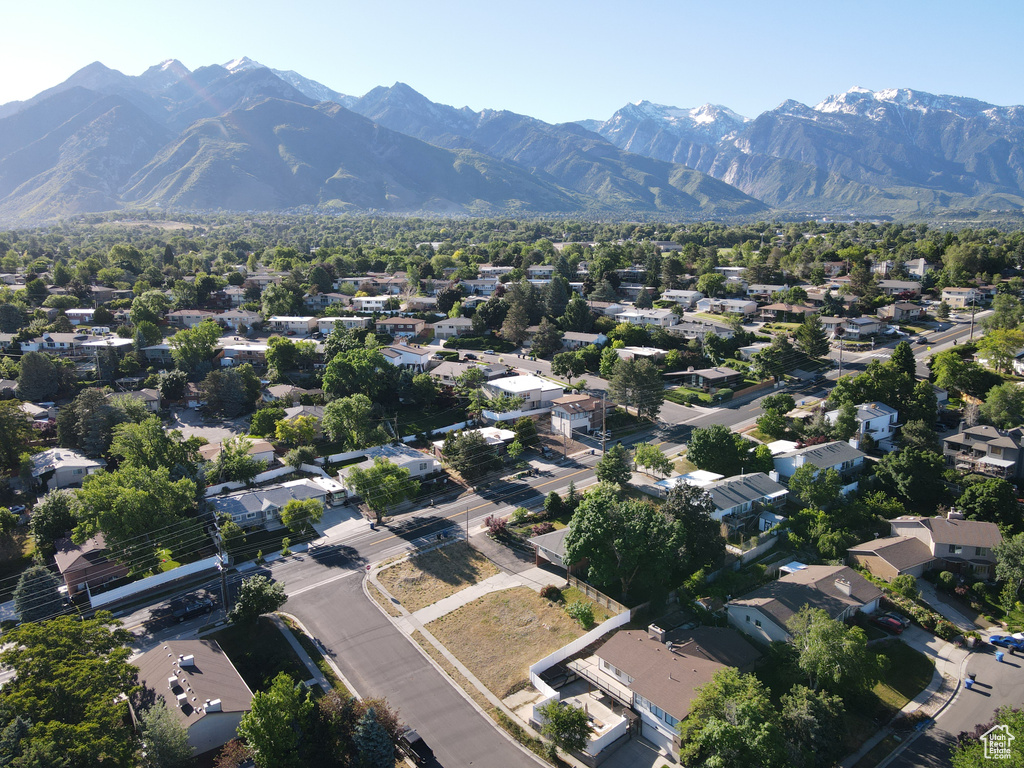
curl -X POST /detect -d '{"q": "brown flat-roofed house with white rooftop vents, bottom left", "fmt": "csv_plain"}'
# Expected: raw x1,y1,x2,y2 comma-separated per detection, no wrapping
132,638,253,755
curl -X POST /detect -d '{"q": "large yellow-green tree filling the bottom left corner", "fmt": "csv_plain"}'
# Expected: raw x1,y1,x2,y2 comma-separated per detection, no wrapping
0,611,137,768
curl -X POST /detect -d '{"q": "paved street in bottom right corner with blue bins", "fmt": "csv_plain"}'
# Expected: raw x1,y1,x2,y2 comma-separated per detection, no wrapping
889,650,1024,768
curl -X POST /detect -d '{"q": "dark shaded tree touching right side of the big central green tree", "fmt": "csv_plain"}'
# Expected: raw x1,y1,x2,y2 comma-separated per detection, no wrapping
662,482,725,577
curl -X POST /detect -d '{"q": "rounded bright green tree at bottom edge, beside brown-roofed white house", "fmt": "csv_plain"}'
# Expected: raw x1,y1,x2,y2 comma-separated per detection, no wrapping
678,667,787,768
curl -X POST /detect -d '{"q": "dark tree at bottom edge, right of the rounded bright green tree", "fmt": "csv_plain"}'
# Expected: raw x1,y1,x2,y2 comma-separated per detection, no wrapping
779,685,847,768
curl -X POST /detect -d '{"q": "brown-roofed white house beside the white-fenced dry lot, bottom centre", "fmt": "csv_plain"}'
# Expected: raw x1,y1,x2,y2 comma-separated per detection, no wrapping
568,627,761,762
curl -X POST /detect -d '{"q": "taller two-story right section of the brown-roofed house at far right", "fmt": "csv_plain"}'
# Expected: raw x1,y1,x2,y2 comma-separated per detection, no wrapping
889,510,1002,580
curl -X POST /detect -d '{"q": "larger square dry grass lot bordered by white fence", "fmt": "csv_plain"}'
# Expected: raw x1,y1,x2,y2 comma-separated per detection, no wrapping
427,587,583,698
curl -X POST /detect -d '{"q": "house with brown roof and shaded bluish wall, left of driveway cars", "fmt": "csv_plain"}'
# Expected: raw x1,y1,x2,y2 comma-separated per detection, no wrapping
725,565,882,642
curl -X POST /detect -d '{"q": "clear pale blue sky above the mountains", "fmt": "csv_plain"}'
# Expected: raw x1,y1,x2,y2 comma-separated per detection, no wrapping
0,0,1024,122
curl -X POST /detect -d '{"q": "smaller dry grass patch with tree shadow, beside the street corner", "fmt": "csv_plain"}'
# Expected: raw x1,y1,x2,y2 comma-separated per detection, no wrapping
378,542,499,612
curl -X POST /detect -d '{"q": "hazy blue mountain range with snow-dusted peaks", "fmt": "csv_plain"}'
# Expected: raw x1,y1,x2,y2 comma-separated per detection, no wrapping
0,58,1024,223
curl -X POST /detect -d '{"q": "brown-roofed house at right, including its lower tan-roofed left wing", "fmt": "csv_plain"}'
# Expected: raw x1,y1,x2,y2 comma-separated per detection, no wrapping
847,510,1002,581
